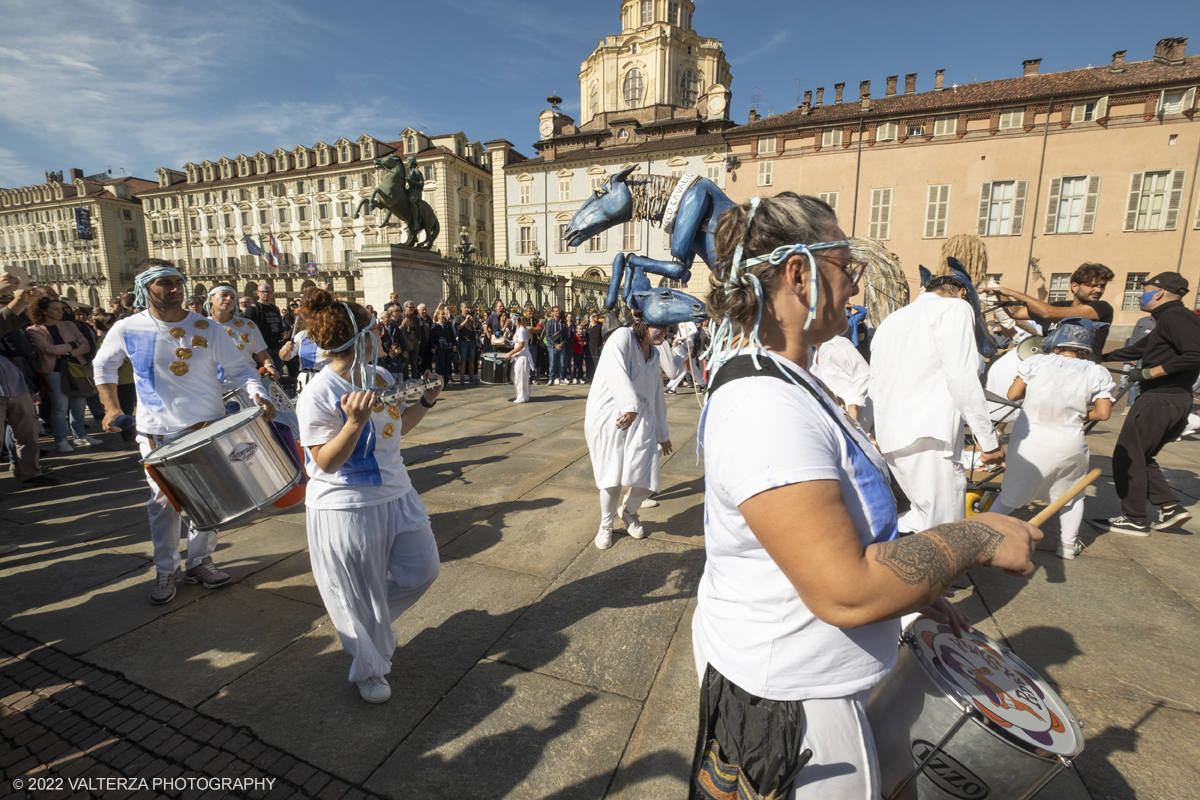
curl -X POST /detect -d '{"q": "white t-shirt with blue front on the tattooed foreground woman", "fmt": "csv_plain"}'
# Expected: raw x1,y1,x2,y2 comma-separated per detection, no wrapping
692,357,900,700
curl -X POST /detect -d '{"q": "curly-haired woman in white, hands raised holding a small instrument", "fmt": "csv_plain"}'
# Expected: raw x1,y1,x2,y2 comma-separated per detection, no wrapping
299,287,442,703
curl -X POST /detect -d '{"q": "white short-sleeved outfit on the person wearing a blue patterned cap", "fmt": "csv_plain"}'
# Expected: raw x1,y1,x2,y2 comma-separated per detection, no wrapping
1001,355,1116,509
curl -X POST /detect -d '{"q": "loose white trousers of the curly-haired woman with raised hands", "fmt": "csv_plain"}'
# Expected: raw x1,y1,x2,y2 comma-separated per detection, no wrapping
306,489,442,682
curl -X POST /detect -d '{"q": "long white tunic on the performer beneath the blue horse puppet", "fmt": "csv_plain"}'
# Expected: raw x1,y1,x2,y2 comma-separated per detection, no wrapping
583,327,670,492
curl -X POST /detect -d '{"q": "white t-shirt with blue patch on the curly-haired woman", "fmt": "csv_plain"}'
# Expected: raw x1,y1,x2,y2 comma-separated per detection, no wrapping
298,368,413,509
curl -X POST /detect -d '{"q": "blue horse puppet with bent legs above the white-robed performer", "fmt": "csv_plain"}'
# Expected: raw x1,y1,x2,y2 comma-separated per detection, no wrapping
565,167,734,325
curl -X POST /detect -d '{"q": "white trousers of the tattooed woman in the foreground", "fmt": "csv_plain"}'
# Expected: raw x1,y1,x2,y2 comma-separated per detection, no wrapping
787,690,880,800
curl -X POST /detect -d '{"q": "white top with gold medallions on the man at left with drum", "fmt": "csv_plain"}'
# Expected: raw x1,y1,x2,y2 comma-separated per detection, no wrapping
95,312,268,434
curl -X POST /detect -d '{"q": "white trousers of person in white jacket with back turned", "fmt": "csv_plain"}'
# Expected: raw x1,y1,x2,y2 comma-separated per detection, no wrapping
883,438,967,533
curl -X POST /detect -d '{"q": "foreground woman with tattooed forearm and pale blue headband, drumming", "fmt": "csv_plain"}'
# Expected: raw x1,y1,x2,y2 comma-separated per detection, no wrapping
692,192,1042,800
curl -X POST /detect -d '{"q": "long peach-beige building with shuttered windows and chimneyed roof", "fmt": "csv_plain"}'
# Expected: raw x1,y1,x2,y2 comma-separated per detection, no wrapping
726,40,1200,335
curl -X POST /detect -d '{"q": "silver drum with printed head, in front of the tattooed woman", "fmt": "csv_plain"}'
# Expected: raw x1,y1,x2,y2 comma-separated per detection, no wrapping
866,618,1084,800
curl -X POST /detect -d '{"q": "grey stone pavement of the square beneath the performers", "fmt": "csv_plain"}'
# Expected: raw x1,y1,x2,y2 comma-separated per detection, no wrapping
0,386,1200,800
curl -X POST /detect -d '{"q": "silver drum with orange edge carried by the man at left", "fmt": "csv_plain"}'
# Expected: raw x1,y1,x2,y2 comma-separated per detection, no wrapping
142,407,301,530
